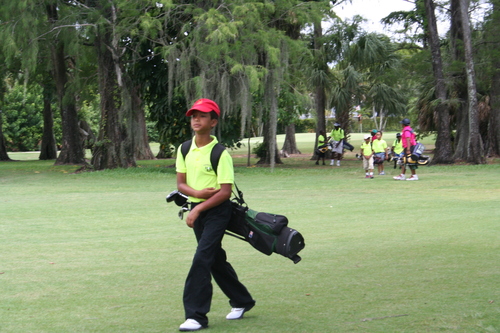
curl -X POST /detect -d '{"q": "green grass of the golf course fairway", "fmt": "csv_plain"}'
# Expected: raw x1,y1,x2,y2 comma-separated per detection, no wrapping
0,134,500,333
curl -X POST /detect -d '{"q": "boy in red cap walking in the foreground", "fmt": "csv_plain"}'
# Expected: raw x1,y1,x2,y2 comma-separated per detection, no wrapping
176,98,255,331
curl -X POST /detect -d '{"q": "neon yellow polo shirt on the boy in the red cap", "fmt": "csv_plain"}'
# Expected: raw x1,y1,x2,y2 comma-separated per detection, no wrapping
175,135,234,202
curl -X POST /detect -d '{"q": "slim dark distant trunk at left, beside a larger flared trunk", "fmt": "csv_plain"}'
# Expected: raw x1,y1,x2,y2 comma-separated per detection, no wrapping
39,83,57,160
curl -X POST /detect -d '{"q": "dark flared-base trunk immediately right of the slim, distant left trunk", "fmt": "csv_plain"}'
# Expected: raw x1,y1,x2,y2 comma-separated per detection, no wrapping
46,3,86,165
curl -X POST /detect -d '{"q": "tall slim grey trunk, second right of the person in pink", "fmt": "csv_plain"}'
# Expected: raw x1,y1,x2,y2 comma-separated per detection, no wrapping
460,0,485,164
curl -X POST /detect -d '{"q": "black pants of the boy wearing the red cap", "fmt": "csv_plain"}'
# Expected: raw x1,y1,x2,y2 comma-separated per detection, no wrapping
184,200,255,326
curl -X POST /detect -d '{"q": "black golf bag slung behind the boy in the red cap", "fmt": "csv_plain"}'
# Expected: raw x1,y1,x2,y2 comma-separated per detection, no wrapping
226,187,305,264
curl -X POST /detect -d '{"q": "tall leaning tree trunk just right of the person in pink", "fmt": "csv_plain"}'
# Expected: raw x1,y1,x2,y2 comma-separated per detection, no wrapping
425,0,453,164
